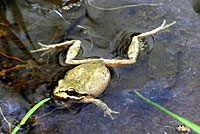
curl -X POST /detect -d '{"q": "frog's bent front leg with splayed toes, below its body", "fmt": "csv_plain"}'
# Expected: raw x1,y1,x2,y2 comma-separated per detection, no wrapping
81,97,119,120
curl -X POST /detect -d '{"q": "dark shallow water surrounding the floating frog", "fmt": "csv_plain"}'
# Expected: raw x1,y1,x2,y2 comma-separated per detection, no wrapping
0,0,200,134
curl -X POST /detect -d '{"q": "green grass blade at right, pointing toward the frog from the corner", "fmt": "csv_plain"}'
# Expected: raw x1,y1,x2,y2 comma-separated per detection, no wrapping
135,91,200,134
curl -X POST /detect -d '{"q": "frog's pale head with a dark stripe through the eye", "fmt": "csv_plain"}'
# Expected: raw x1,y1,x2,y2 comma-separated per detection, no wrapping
53,80,87,100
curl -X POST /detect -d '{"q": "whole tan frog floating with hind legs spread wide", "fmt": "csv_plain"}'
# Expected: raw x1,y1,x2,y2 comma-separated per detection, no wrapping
32,20,176,119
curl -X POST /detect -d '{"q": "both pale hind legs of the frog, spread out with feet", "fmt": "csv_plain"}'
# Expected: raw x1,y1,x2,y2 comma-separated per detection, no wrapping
31,20,176,66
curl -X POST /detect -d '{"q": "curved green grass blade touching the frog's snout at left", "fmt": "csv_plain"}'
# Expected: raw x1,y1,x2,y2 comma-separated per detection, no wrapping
12,98,51,134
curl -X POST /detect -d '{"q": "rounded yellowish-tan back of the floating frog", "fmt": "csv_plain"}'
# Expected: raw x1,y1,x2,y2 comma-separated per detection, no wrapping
64,61,110,96
